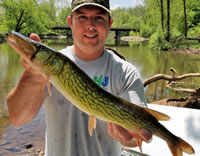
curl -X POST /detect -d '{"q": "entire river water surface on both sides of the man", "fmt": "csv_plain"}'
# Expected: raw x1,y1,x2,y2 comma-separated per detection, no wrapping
0,40,200,156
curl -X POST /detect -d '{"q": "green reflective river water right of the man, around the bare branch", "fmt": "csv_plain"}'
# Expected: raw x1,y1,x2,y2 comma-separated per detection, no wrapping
116,46,200,102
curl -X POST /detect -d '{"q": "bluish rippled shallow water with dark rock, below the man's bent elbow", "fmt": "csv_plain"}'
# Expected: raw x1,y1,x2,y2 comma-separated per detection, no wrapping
0,109,45,156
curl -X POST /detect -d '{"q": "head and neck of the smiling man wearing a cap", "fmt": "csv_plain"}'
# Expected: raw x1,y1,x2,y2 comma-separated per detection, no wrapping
68,1,113,61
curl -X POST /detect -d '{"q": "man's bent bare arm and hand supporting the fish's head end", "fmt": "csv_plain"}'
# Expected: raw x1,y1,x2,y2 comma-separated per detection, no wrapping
7,35,47,126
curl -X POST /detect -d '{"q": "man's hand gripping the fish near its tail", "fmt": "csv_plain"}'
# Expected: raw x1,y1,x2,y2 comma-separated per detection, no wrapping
107,123,152,147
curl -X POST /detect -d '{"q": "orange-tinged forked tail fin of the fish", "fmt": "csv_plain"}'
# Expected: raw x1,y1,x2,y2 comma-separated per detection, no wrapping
168,137,195,156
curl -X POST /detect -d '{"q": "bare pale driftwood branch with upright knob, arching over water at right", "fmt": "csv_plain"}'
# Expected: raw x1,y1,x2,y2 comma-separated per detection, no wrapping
143,68,200,87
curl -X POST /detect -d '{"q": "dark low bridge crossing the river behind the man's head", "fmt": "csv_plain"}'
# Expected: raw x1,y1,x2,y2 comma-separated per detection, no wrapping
51,26,139,45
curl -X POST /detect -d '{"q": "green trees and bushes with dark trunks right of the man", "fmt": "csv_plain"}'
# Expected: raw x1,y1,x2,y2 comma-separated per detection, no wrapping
112,0,200,50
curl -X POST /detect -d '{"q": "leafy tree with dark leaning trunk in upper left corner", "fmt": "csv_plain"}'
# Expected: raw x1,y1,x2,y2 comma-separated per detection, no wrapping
0,0,52,35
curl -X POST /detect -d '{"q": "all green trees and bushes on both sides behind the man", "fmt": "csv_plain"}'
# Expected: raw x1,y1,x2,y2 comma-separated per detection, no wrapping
0,0,200,50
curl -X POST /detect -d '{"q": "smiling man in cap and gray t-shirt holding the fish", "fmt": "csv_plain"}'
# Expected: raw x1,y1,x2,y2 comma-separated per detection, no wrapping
7,0,152,156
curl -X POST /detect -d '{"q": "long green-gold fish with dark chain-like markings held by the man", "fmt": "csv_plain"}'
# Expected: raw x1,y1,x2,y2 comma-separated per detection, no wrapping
6,31,195,156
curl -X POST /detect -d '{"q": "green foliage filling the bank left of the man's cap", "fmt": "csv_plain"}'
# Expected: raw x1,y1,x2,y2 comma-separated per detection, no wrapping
0,0,69,35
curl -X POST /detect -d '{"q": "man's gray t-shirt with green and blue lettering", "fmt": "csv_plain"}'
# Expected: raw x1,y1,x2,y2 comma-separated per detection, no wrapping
44,46,146,156
